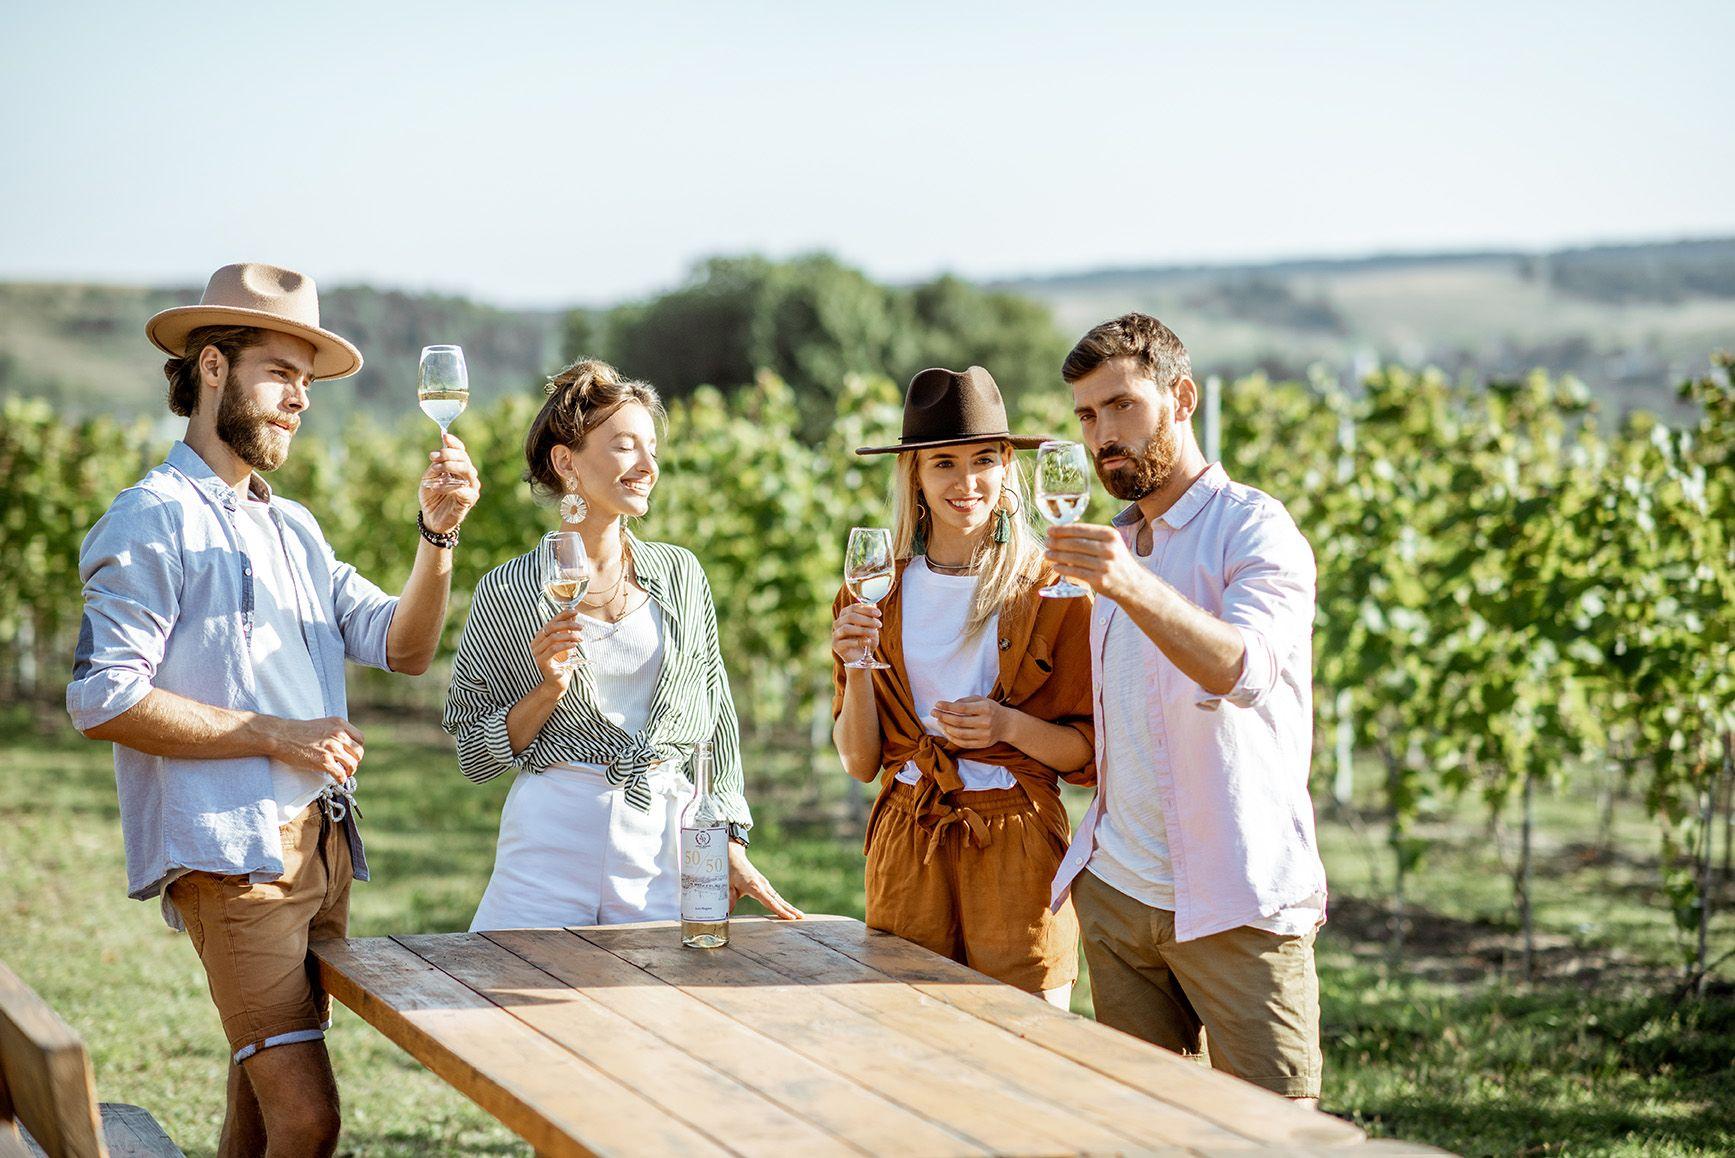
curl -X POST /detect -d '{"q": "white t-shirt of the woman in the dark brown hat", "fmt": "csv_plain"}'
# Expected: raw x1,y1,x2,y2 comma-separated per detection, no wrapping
897,556,1018,792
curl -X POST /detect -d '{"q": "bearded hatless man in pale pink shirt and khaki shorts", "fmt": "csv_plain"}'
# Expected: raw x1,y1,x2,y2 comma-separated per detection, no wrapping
1048,313,1326,1104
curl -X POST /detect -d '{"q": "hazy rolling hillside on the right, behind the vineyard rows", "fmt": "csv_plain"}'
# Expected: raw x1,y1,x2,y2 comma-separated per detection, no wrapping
998,238,1735,417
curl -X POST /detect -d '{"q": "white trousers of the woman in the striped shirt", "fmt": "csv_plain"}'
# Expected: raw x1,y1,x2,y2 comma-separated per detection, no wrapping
470,764,692,932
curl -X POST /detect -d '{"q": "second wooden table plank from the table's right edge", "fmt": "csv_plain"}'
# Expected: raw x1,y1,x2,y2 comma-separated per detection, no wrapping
730,922,1263,1153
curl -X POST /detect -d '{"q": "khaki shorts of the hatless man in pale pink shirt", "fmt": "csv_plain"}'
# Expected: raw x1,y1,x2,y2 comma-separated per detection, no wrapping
1072,872,1320,1097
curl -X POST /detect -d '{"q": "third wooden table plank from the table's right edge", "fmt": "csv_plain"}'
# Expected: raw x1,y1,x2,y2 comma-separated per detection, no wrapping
574,925,1128,1155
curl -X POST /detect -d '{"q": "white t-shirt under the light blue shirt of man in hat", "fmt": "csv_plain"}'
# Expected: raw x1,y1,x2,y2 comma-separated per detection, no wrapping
234,498,331,825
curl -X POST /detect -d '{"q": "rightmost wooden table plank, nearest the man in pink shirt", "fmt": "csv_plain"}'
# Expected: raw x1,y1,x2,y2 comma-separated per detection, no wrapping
791,922,1365,1149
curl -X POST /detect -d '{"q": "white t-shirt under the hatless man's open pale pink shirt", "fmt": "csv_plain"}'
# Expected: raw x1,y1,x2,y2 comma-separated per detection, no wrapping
1090,538,1324,936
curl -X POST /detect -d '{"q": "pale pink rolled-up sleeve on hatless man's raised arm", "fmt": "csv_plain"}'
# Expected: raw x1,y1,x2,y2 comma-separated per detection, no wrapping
1194,507,1317,712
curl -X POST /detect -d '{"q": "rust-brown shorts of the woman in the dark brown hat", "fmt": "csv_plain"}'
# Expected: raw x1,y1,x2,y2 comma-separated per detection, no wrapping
868,785,1079,993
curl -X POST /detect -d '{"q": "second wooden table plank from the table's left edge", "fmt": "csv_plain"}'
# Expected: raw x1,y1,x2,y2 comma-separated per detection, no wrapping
392,932,862,1158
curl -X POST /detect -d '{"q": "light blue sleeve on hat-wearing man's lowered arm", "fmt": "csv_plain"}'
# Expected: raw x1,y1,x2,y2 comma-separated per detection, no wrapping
66,488,182,731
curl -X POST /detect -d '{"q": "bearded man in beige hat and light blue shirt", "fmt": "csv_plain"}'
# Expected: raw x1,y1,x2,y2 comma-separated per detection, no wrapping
66,264,481,1155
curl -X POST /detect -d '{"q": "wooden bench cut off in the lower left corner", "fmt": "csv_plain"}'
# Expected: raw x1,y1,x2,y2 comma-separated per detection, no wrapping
0,964,180,1158
